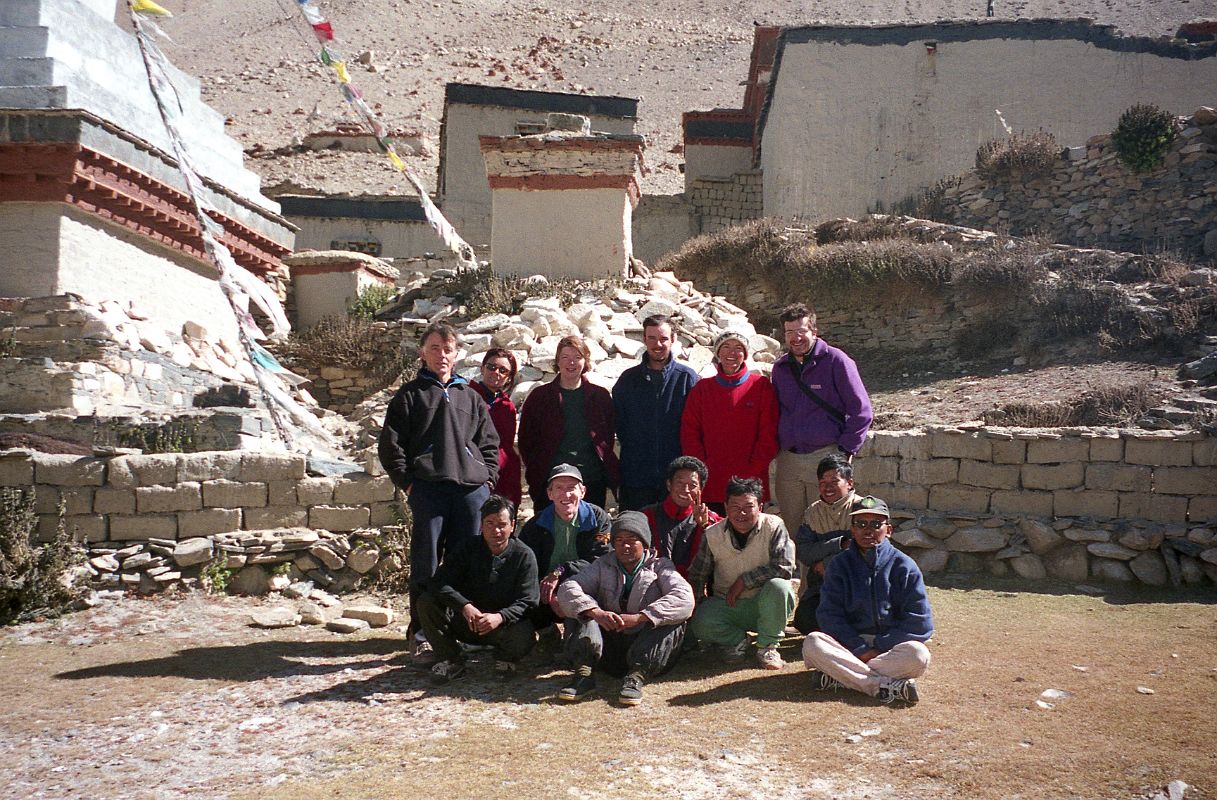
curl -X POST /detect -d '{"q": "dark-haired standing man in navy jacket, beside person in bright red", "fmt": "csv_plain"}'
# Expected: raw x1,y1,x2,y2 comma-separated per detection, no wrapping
612,314,697,510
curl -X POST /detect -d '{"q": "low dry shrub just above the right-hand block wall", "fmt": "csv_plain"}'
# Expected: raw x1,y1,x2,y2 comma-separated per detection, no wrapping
985,380,1157,427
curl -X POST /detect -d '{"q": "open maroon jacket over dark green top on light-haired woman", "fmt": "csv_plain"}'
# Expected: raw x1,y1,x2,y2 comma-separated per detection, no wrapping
520,377,621,492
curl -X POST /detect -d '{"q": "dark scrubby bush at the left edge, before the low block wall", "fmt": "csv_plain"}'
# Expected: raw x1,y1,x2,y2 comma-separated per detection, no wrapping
0,487,80,625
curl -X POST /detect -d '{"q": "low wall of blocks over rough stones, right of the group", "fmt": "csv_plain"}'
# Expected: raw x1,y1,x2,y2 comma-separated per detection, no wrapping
854,425,1217,586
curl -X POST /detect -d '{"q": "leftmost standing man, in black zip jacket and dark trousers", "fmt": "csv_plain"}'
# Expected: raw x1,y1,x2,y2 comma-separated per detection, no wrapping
378,323,499,658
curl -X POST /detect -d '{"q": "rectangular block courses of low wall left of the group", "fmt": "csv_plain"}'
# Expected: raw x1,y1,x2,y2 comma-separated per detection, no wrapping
0,449,397,547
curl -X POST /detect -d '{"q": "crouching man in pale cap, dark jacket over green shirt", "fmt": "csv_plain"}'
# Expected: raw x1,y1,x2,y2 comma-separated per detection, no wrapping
520,464,612,631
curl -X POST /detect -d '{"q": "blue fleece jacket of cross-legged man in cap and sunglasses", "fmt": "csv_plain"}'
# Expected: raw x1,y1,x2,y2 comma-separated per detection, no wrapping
815,541,933,655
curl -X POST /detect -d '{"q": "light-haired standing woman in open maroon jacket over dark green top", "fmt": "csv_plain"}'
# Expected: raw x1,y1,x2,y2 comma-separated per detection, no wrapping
520,336,619,511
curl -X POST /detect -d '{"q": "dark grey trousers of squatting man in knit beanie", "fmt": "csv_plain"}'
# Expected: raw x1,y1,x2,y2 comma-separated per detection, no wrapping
565,619,686,678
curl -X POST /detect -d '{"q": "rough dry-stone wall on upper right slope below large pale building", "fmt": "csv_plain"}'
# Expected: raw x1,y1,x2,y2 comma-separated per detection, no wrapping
943,108,1217,257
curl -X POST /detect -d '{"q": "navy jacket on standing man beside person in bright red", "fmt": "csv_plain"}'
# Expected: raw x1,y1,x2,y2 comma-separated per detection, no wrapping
612,351,697,487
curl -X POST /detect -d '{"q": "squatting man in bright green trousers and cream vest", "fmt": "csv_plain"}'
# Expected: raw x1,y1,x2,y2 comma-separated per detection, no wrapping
689,477,795,670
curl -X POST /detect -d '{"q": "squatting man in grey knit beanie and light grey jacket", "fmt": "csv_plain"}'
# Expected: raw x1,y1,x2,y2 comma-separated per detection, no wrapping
557,511,694,706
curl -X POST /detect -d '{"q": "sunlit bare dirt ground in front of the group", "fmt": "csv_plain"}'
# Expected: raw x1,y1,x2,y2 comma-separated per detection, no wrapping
0,581,1217,800
